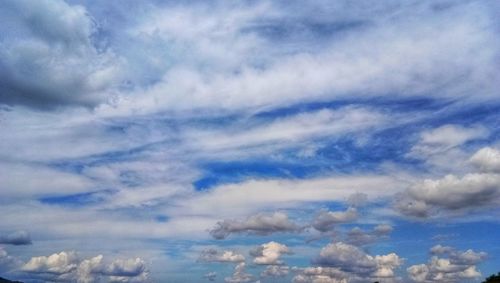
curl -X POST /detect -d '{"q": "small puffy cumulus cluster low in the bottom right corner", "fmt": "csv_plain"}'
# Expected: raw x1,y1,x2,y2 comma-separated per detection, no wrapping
407,245,487,283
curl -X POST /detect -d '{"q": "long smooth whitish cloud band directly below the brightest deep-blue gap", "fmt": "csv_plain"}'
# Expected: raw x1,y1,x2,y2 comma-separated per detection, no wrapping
174,174,407,217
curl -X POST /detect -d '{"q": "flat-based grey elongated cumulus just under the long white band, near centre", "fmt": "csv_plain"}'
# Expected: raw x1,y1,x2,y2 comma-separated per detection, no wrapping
209,212,301,240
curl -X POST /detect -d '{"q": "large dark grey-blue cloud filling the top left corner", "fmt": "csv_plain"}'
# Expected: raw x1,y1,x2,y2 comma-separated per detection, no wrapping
0,0,121,108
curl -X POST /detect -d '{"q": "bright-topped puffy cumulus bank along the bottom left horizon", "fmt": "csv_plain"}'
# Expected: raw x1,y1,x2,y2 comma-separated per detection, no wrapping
20,252,148,283
